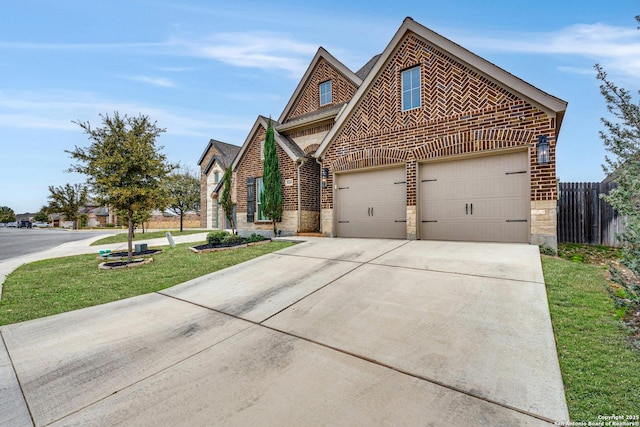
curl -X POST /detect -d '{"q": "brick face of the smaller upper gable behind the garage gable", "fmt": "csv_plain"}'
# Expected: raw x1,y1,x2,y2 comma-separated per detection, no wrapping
283,58,358,123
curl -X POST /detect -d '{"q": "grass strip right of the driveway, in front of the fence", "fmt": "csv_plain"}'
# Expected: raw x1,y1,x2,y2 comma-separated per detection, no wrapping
542,245,640,422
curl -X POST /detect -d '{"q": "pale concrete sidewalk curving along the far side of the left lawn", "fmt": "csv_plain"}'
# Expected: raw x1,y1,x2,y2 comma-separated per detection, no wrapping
0,231,209,299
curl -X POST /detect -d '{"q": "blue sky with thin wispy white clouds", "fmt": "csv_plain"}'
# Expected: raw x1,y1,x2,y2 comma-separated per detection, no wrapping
0,0,640,214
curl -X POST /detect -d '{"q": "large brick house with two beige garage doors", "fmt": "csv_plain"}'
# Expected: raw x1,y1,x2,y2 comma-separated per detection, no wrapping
222,18,567,248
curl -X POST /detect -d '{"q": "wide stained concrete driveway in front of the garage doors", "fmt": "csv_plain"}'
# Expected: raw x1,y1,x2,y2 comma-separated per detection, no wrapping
0,239,568,427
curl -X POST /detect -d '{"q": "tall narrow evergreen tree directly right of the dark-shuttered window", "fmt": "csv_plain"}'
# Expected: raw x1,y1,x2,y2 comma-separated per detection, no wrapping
260,119,282,236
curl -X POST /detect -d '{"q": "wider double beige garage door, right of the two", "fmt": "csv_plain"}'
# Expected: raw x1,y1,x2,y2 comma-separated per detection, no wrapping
419,152,531,243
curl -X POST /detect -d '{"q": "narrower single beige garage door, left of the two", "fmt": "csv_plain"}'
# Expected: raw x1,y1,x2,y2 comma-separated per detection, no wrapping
336,166,407,239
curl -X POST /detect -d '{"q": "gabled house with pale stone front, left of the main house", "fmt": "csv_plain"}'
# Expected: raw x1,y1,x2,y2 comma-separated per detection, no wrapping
198,139,240,228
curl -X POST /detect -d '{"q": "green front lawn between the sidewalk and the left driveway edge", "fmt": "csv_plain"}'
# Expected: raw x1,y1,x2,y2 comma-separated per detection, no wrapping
0,242,292,325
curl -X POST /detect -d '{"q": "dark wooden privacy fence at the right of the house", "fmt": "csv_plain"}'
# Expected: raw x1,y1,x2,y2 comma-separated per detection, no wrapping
558,182,622,246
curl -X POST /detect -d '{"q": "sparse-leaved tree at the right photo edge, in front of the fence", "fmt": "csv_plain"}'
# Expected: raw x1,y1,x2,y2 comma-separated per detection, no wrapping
595,16,640,308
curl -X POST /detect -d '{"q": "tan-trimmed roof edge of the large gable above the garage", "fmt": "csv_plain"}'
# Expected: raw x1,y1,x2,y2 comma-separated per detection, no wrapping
315,17,567,158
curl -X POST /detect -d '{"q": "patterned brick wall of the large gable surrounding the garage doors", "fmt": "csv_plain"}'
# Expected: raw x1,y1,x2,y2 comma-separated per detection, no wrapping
322,34,557,209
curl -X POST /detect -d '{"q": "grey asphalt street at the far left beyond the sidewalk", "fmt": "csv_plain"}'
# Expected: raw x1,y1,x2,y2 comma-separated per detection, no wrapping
0,227,117,261
